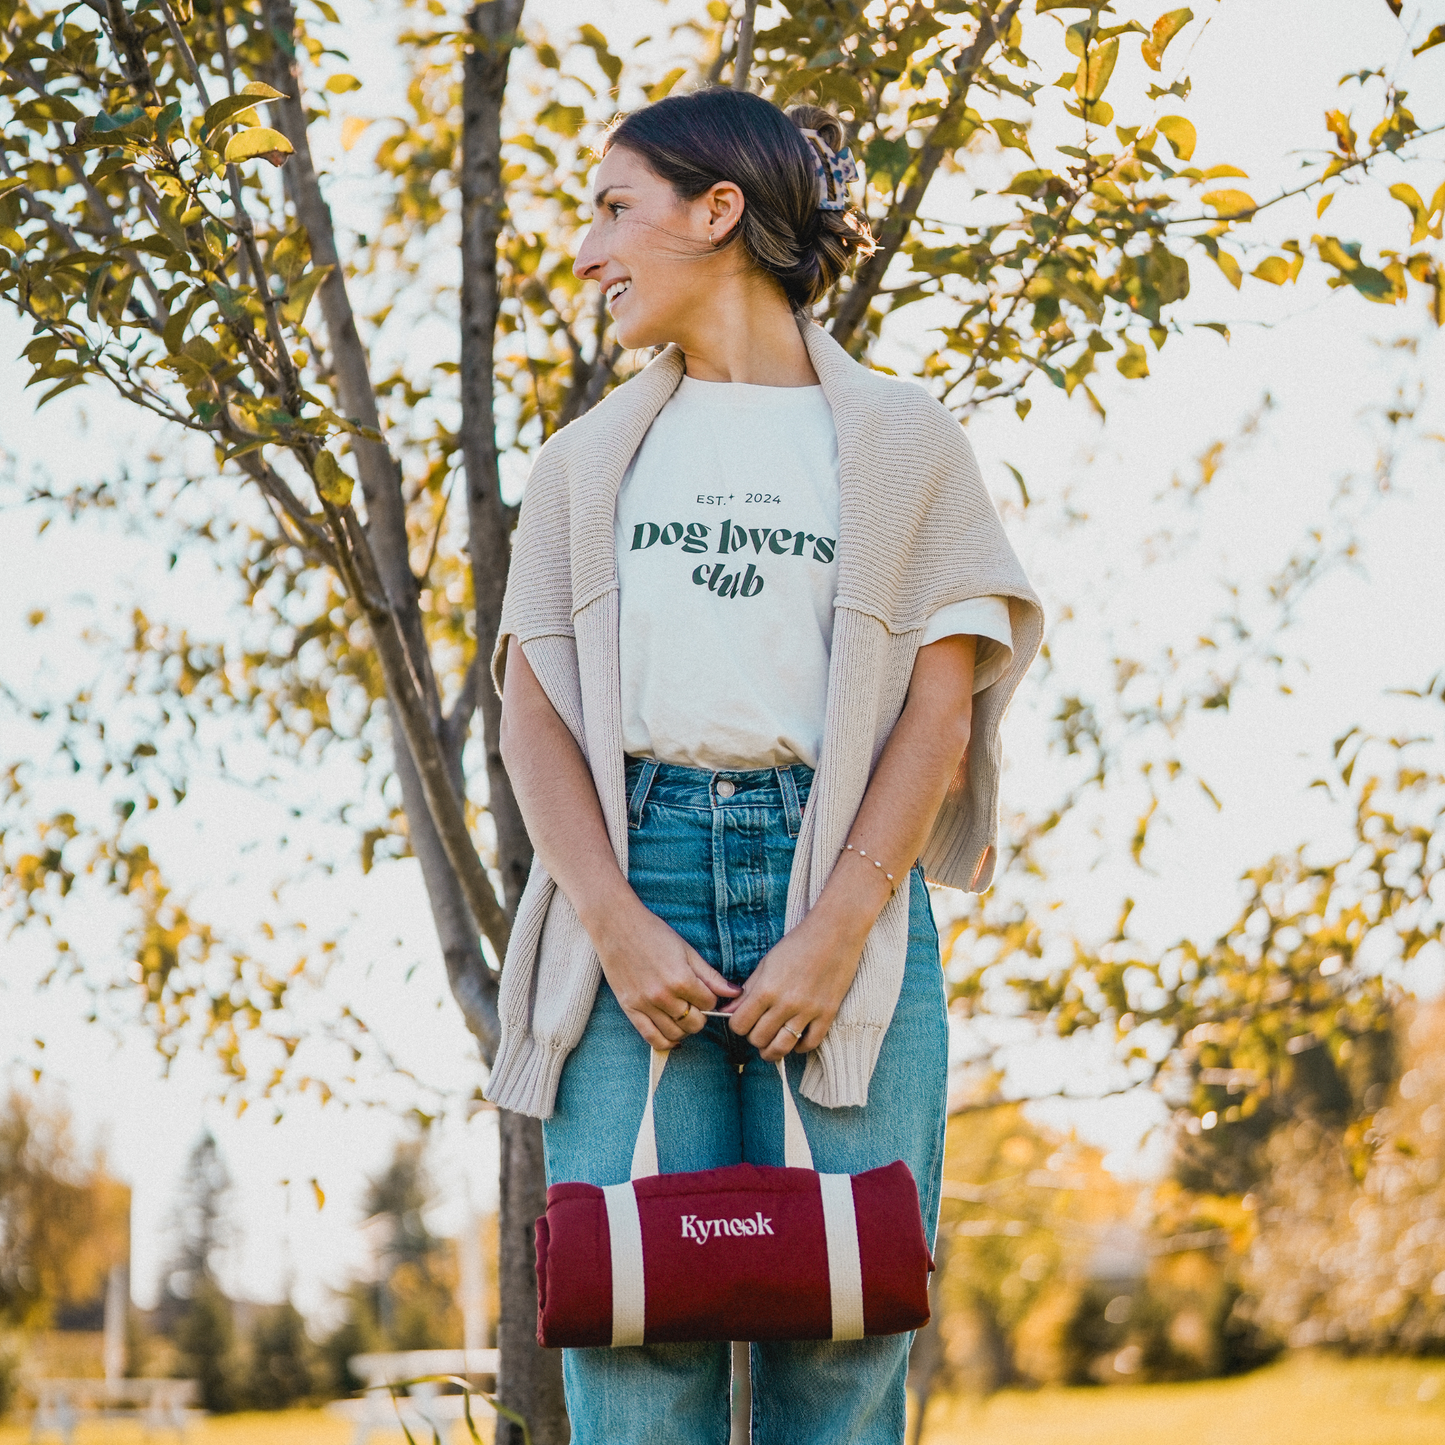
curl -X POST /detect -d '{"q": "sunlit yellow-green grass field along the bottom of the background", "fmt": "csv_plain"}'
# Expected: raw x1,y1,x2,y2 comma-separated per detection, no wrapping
11,1357,1445,1445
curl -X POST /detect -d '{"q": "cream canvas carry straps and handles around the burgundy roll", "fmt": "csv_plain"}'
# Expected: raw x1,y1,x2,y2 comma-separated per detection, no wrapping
603,1049,863,1348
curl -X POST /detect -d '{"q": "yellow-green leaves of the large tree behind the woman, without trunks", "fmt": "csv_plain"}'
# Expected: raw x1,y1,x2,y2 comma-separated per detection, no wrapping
0,0,1445,1088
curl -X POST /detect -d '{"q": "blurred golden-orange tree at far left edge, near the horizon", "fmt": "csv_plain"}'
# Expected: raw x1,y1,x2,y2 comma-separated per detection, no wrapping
0,1091,130,1329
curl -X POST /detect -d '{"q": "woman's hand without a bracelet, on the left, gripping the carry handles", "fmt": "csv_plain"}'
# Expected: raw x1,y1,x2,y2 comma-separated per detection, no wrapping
588,894,739,1049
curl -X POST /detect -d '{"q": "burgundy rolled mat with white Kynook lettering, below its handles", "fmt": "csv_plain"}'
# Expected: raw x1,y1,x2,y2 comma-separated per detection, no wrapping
536,1098,933,1348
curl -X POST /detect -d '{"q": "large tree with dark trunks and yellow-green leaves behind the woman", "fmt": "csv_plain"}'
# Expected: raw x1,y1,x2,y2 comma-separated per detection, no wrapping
0,0,1445,1442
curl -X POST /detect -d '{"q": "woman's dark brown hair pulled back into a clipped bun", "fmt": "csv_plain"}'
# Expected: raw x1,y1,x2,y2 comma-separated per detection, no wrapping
603,87,873,309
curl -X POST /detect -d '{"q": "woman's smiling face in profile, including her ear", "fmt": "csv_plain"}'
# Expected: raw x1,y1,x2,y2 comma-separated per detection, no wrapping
572,146,743,350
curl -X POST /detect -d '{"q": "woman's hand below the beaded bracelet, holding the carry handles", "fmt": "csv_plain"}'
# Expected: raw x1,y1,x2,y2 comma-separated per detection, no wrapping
724,913,861,1064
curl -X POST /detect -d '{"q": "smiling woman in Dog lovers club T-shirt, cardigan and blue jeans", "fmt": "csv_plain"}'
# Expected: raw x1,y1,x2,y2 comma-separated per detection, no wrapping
488,91,1042,1445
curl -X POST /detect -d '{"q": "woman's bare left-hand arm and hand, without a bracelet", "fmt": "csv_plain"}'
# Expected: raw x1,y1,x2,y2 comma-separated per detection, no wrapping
501,639,739,1049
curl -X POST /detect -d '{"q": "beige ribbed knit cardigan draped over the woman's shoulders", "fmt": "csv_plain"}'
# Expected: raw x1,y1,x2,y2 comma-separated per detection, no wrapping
486,322,1043,1118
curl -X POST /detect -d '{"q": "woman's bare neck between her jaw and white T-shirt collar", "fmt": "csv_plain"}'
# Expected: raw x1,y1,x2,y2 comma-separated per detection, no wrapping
676,276,818,386
